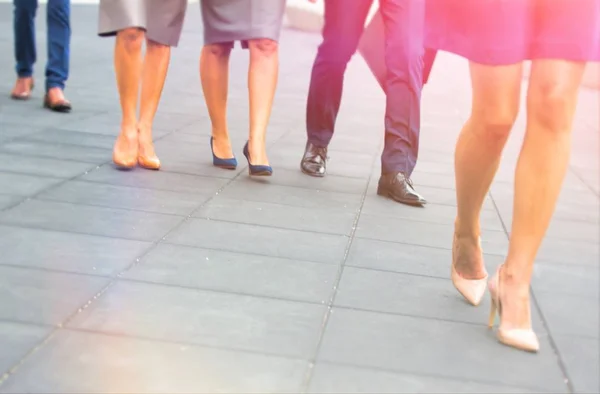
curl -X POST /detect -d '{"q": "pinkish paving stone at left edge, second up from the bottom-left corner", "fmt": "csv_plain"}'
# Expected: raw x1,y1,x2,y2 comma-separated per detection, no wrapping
0,266,109,325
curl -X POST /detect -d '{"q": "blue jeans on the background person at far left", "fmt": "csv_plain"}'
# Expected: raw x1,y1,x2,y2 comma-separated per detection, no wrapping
13,0,71,90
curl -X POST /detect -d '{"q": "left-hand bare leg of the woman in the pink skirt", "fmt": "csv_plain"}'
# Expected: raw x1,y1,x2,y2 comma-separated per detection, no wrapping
455,63,522,279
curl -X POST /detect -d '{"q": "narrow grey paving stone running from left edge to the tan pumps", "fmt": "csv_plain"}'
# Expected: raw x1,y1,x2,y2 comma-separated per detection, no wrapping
0,140,111,164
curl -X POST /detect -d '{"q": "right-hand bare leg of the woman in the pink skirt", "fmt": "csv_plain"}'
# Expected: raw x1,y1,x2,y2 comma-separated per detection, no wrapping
501,60,585,329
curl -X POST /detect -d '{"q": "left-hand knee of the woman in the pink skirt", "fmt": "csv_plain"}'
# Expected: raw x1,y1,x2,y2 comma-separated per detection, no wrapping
470,104,519,146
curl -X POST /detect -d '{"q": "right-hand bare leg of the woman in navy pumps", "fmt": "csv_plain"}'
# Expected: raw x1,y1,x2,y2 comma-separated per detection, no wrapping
248,39,279,165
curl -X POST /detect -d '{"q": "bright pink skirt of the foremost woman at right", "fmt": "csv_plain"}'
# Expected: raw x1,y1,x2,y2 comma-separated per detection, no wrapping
425,0,600,65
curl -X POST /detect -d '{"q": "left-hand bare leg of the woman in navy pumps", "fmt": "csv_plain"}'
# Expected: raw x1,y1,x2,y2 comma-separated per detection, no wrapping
200,44,233,159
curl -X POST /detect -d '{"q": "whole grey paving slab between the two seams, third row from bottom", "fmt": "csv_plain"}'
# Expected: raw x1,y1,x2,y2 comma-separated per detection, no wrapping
123,244,338,303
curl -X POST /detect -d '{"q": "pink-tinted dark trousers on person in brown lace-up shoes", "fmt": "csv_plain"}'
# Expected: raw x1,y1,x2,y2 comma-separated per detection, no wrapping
306,0,429,177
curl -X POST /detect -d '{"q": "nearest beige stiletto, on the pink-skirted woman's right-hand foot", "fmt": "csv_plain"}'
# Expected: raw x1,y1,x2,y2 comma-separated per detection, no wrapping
488,266,540,353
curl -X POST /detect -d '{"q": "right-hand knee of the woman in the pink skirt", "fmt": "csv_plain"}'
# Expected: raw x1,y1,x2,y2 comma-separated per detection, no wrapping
527,81,576,133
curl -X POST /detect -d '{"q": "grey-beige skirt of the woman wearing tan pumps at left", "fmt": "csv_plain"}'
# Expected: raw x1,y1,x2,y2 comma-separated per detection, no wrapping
98,0,188,46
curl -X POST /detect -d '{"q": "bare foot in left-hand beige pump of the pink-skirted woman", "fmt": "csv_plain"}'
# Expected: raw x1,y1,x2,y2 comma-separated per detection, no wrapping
452,232,487,280
